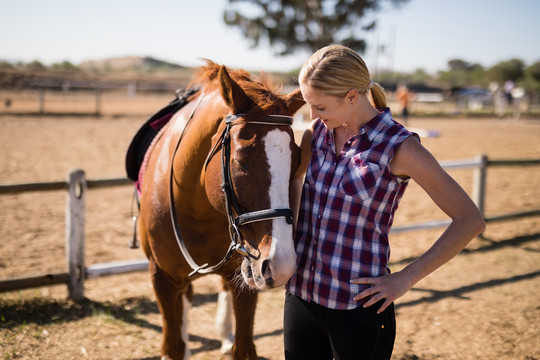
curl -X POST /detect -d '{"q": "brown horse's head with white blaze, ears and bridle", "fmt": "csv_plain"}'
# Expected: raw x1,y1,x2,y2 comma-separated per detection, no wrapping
205,66,304,289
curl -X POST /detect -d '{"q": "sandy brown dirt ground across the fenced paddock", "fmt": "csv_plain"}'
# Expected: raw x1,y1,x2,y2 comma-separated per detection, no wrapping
0,108,540,360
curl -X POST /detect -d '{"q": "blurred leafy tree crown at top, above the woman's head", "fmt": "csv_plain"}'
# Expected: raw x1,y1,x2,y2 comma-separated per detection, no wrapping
224,0,410,55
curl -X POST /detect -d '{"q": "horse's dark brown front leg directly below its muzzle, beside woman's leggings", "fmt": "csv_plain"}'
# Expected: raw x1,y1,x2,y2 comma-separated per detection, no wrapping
229,284,258,360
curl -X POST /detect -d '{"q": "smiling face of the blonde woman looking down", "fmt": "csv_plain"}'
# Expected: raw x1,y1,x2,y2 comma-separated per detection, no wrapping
300,84,353,130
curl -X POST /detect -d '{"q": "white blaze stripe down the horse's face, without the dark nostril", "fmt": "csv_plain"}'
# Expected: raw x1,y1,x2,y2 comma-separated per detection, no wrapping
264,129,296,286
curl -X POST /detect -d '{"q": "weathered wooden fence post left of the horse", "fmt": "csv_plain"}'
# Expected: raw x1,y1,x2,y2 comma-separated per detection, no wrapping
66,169,87,301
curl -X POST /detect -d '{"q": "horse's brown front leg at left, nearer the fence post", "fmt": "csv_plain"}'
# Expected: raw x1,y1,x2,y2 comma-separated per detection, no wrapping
149,257,192,360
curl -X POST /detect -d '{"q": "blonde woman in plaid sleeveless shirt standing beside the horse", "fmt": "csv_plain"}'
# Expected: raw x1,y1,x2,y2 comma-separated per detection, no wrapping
284,45,485,360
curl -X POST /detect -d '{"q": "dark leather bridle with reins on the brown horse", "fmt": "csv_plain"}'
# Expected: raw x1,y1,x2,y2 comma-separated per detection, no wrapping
169,100,293,277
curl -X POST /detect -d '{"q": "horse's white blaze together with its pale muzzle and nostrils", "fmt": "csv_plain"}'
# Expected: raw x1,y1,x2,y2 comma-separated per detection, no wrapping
242,129,296,289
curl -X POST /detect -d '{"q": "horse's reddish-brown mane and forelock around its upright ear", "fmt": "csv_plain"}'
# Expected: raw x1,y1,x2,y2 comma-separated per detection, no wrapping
190,60,283,113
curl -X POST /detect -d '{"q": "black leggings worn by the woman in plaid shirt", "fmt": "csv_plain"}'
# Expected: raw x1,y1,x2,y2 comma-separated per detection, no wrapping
284,293,396,360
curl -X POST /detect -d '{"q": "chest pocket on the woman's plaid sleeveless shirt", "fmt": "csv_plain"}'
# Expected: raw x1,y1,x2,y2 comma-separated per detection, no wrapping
340,157,383,200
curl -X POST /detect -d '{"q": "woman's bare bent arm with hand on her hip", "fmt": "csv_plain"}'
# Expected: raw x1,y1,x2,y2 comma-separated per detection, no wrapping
351,137,485,312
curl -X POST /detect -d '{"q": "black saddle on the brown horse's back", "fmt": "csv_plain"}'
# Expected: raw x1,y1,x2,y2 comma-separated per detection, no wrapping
126,89,198,182
